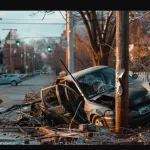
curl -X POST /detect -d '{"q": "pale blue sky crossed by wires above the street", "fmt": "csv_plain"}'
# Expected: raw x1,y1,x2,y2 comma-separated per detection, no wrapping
0,11,66,42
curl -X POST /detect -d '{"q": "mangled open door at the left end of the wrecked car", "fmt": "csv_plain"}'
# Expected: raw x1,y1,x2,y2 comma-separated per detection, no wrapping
41,85,74,125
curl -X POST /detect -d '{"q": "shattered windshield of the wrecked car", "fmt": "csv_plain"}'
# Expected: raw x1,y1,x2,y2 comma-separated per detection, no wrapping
78,68,115,98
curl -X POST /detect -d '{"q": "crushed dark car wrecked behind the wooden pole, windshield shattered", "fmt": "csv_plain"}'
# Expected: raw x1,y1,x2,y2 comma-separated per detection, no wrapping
41,66,150,128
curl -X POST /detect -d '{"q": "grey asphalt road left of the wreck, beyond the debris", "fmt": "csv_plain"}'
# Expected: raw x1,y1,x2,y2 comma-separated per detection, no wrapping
0,75,54,107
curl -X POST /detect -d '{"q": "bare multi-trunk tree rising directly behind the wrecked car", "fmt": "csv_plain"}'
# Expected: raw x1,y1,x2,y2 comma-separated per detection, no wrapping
79,11,116,65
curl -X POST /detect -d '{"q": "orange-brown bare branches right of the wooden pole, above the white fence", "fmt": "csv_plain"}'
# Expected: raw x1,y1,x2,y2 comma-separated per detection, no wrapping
129,11,150,72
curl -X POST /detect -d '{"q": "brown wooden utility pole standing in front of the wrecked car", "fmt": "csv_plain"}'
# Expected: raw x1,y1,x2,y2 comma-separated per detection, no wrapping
115,11,129,133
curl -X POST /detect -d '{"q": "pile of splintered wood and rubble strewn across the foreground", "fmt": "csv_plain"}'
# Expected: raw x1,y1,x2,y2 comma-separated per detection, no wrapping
0,93,150,145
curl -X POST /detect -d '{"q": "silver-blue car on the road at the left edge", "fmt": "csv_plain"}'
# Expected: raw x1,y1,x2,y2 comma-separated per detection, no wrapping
0,74,22,86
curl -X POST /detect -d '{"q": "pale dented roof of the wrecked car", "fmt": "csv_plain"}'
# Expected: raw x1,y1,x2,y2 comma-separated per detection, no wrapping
58,65,109,80
